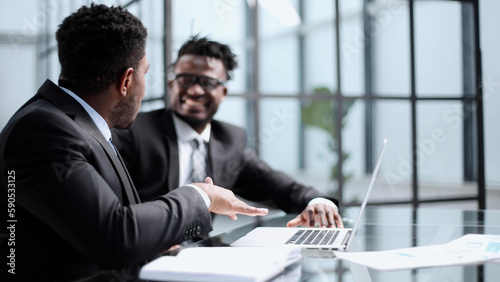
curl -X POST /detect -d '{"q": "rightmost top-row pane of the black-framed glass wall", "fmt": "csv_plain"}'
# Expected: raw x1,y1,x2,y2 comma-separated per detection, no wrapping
415,1,463,97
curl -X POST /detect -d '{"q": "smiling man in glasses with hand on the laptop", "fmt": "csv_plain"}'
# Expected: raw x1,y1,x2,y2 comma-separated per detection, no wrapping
115,36,343,227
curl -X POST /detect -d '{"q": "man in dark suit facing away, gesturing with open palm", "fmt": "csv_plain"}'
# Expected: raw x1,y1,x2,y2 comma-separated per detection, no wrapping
0,4,267,281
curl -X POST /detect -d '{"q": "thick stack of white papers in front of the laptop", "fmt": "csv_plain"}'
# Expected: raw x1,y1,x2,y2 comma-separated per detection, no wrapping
139,246,301,282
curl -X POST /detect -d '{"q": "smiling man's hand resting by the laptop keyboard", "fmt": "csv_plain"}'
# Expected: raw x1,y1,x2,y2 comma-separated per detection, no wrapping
286,204,344,228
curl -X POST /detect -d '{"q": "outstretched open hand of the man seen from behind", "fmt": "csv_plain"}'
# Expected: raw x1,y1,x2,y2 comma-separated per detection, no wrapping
193,177,269,220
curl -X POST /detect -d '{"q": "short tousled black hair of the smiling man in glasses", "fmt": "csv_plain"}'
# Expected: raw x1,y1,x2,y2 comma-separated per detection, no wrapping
172,35,238,80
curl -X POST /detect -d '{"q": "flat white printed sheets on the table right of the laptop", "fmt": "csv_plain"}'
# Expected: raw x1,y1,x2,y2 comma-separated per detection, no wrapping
335,234,500,270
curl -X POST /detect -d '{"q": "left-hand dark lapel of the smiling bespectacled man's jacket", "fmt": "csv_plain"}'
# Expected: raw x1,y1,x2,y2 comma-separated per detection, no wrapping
161,110,179,191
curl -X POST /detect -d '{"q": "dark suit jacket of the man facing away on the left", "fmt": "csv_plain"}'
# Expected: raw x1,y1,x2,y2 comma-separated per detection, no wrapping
0,81,211,281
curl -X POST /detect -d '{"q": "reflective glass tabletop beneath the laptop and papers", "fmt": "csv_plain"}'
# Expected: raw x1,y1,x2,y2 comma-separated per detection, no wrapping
166,207,500,282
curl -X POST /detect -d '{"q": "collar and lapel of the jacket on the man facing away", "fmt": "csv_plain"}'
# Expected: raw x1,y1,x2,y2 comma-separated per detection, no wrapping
38,80,139,204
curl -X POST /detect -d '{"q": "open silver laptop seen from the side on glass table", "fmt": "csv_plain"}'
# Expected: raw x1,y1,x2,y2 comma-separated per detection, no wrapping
231,139,387,251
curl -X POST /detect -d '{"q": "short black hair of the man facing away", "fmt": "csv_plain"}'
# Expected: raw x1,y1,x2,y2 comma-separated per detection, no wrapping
56,4,147,95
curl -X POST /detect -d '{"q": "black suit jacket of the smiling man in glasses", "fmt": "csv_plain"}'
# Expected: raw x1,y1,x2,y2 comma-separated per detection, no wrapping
113,109,338,213
